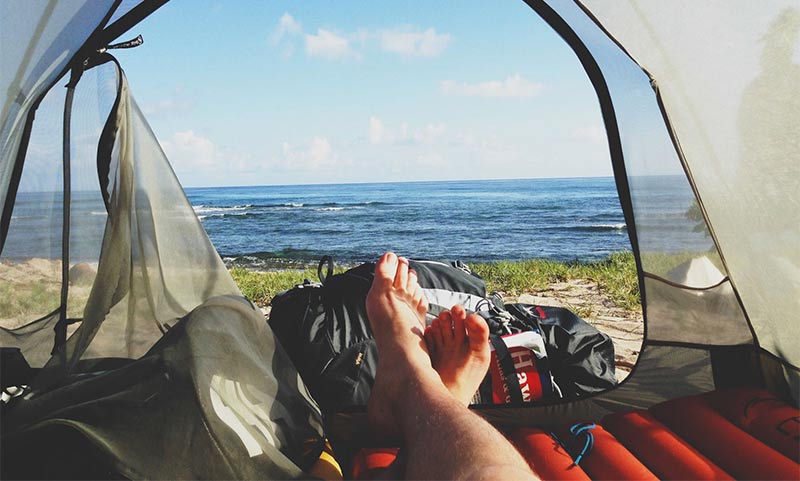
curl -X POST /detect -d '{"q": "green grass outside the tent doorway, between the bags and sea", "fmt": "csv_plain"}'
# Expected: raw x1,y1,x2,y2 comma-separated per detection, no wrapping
231,253,639,314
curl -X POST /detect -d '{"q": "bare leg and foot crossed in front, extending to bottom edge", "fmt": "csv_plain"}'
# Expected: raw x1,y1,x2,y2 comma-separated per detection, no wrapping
367,253,536,479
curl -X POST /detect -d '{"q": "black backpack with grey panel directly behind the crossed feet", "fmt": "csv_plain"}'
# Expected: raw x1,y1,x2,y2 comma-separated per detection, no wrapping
269,256,486,412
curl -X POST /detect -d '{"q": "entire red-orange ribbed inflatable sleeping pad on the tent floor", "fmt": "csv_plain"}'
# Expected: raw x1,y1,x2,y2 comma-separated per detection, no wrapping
348,389,800,480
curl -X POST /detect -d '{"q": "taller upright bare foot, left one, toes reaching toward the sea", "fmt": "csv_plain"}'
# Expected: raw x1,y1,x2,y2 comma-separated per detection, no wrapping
366,252,434,436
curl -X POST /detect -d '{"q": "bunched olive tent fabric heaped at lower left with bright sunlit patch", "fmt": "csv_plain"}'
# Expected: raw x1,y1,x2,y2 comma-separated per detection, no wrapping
4,296,322,479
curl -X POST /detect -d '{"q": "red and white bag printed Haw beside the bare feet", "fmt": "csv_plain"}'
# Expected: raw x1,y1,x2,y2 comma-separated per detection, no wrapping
478,330,560,404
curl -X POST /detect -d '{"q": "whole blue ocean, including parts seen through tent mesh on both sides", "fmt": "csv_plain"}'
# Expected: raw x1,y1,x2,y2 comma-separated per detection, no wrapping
2,176,710,268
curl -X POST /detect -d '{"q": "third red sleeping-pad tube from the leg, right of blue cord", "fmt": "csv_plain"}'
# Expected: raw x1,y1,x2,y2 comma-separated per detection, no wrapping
603,411,733,480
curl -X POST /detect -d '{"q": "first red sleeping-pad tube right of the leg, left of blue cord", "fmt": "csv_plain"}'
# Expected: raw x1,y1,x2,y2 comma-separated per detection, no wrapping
508,428,591,481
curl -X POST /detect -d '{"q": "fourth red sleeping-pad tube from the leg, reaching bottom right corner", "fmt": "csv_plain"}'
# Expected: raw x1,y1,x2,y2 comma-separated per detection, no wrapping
650,396,800,480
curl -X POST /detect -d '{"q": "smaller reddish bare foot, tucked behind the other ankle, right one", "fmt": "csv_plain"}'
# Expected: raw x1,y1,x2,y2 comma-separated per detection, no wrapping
425,306,491,406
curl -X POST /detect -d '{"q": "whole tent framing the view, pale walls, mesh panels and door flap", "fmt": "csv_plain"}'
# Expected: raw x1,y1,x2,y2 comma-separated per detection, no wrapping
0,0,800,478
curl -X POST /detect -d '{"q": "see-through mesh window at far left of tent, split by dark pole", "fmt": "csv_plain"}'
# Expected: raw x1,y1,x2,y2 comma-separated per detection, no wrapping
0,64,117,367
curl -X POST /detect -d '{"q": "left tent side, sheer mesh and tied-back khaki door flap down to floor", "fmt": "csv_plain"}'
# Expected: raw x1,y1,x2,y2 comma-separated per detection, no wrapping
0,4,323,479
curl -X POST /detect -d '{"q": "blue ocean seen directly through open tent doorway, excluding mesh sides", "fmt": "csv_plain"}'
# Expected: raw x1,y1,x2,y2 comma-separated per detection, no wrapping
186,178,631,266
